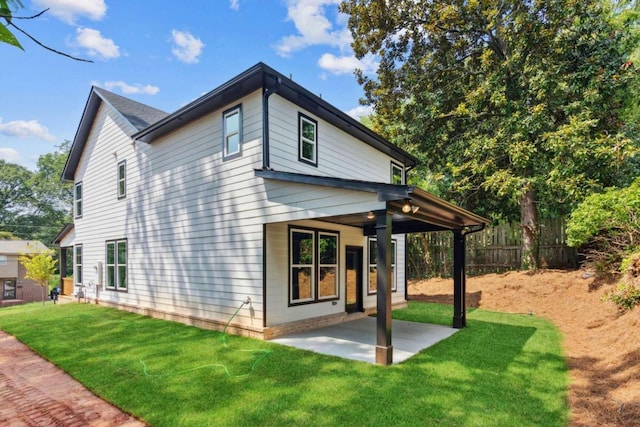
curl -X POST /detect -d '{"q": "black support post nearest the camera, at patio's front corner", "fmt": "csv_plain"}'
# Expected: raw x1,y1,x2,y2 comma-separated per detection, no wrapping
376,210,393,365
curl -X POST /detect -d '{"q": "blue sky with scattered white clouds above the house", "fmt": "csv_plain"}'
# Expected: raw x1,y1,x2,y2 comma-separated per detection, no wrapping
0,0,377,170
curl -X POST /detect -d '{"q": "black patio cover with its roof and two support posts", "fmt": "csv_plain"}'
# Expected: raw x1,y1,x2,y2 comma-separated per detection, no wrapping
255,169,489,365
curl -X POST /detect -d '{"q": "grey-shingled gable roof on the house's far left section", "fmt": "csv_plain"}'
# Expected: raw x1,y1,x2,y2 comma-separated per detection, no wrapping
62,86,167,181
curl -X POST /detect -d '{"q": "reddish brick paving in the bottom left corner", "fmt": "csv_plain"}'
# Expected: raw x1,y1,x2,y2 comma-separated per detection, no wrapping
0,331,145,427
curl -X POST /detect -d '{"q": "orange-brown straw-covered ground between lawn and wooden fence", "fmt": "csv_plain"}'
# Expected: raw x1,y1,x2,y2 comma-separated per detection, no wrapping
409,270,640,427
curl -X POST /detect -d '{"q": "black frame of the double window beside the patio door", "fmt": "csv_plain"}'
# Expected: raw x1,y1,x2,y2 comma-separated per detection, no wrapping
287,225,340,307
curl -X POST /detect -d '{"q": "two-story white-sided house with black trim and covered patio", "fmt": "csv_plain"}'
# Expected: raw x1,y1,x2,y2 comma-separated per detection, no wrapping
59,63,486,364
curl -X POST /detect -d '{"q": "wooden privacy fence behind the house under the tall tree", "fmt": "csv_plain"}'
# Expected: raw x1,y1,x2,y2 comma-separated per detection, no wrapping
407,219,577,278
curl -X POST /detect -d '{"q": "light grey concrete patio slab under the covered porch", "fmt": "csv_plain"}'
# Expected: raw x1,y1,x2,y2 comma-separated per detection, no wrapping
271,317,458,363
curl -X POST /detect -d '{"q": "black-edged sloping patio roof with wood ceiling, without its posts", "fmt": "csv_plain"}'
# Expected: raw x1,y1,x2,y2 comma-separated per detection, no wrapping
255,170,489,235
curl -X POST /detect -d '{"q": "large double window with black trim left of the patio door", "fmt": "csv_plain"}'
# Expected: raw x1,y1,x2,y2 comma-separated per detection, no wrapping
289,227,339,305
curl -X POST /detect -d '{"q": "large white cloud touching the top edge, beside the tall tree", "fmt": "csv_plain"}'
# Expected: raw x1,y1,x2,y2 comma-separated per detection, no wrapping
276,0,353,57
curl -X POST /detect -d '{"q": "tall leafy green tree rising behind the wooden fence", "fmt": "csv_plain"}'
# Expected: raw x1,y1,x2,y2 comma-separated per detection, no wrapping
341,0,638,269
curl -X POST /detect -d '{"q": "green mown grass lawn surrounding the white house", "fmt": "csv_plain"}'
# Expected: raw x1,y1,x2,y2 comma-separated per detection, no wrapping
0,303,568,427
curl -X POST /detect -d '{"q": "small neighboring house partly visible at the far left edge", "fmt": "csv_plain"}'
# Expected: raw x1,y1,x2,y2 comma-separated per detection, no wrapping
0,240,48,306
